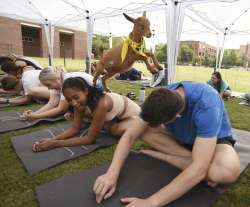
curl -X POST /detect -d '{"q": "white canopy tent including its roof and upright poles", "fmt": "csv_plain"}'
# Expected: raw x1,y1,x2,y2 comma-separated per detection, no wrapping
0,0,250,83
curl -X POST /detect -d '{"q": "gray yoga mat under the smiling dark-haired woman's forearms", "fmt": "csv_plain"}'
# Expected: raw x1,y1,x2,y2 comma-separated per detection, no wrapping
11,125,117,175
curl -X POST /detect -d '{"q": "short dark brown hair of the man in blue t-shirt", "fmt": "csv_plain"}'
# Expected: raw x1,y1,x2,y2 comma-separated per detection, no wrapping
141,88,184,126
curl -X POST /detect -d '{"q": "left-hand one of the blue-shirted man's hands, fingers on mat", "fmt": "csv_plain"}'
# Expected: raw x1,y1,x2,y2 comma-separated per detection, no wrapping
93,173,117,203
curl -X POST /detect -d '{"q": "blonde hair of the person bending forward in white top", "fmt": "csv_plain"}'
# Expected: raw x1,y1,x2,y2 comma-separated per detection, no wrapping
39,66,64,81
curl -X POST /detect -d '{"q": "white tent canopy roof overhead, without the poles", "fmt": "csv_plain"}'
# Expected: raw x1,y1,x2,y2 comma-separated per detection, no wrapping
0,0,250,47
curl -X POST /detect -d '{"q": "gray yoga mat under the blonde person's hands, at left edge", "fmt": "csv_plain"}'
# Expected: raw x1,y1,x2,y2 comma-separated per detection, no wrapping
0,110,64,133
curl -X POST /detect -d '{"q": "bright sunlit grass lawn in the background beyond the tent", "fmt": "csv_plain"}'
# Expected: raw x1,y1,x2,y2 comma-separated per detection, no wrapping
34,58,250,92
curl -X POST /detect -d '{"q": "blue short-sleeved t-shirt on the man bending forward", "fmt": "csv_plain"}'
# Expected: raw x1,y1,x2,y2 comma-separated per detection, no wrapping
165,82,232,144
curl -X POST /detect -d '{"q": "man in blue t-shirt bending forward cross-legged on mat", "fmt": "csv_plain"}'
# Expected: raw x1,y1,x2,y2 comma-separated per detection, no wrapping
93,82,240,207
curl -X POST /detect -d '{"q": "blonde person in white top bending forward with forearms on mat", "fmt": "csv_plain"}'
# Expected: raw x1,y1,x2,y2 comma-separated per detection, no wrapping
23,67,102,120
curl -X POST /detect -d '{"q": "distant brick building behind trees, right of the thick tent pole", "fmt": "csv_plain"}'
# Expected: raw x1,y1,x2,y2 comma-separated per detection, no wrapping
180,40,216,58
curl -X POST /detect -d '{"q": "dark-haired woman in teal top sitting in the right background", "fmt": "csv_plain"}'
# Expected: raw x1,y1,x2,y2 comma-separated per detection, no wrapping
207,71,232,100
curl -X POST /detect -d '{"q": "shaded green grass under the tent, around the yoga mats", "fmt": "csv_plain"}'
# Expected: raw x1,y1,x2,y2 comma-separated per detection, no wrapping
0,81,250,207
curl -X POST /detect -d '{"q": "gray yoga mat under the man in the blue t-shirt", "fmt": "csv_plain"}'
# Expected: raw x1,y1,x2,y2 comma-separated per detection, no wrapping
36,130,250,207
